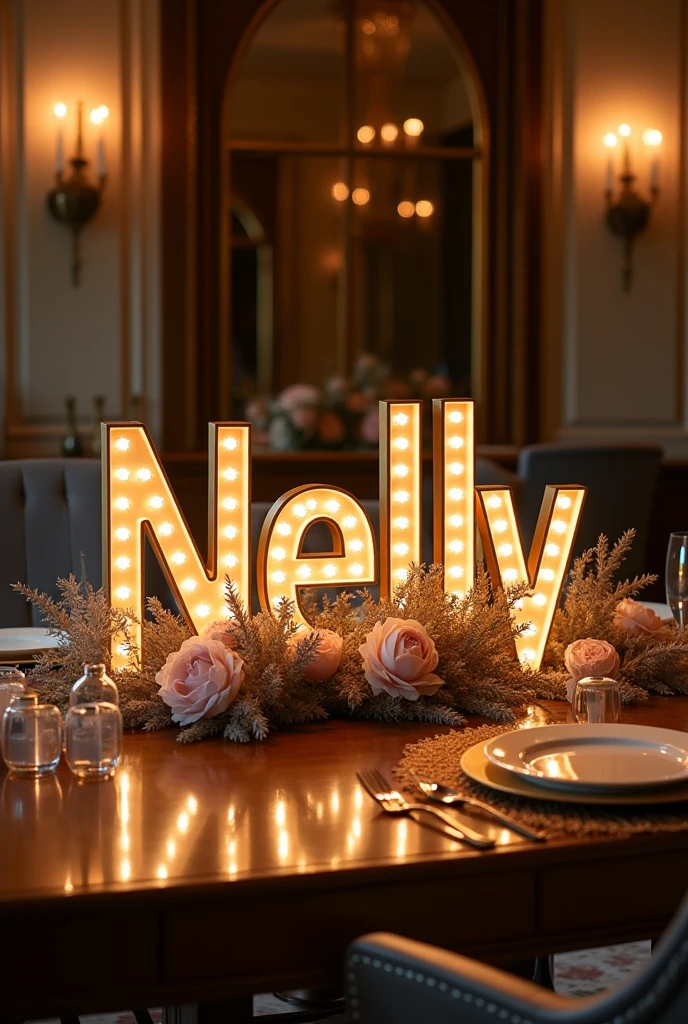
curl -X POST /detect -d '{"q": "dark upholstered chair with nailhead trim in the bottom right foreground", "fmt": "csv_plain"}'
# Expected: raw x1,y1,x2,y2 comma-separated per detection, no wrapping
346,899,688,1024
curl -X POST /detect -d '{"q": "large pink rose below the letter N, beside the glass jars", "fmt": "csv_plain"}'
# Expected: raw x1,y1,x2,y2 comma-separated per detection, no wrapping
156,637,244,725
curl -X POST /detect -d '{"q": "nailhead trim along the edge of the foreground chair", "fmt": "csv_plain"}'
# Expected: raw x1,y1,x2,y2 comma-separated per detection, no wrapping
347,940,688,1024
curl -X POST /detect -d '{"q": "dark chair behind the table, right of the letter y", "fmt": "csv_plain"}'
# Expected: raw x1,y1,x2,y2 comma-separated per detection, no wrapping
516,444,662,578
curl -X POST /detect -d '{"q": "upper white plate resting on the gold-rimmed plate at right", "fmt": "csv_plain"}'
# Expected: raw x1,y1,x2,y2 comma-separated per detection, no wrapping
484,724,688,793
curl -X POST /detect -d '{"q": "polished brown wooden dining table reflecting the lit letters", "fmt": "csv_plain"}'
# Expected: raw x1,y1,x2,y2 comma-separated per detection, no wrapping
0,697,688,1021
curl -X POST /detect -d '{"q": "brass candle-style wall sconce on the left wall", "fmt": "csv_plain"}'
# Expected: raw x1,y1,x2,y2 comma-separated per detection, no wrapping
47,102,110,288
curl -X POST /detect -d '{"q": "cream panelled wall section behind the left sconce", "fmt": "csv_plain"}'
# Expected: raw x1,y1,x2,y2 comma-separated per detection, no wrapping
0,0,160,456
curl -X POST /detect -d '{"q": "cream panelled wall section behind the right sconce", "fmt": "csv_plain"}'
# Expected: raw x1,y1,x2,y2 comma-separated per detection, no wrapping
543,0,688,456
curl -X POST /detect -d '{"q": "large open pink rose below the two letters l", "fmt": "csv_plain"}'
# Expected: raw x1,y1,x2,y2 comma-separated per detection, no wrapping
358,616,444,700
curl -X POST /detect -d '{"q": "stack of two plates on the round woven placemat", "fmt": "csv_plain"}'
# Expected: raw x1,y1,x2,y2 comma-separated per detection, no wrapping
461,725,688,804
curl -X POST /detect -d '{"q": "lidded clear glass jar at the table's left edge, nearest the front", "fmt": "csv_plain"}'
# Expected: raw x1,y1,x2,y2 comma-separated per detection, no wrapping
2,690,62,775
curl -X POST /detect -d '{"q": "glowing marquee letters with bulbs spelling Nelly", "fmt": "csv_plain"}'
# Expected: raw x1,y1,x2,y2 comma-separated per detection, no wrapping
102,398,586,669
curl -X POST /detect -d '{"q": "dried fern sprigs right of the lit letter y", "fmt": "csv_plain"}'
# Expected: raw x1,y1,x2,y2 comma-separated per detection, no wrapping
545,529,688,703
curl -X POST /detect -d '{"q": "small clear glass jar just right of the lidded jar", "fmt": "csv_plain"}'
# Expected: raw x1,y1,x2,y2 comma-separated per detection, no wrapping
65,700,122,778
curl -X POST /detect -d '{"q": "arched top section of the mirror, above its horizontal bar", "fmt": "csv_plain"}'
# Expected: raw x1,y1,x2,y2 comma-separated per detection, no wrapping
224,0,482,149
